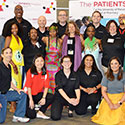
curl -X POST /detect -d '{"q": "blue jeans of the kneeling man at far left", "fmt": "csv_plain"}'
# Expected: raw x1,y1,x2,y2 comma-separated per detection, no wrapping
0,91,27,123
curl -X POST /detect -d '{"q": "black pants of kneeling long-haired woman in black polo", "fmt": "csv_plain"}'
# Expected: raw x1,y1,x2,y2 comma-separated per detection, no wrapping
75,92,101,115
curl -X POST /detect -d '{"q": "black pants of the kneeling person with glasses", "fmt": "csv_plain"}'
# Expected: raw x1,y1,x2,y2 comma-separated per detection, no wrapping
51,97,75,120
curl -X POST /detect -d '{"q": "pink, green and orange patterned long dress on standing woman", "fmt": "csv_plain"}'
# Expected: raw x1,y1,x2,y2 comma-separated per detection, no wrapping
45,39,61,93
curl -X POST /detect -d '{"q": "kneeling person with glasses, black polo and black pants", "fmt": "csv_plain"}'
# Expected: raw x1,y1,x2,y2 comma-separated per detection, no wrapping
51,56,80,120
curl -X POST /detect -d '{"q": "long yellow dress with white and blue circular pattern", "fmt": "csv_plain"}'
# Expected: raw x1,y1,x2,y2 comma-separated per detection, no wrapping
9,35,24,89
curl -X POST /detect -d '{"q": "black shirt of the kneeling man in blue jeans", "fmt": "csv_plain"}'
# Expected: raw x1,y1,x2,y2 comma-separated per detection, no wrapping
0,61,11,92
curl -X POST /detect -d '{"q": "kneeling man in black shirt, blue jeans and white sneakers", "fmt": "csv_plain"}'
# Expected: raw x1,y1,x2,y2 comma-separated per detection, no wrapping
0,47,30,123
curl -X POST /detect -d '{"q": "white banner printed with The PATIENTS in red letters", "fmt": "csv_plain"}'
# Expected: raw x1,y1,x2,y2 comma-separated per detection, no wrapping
69,0,125,25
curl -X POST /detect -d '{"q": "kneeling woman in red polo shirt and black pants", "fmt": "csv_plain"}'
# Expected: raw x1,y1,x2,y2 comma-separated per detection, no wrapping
24,54,53,119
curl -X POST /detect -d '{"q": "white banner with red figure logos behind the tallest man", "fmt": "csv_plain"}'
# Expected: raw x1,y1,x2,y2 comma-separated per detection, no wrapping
0,0,56,34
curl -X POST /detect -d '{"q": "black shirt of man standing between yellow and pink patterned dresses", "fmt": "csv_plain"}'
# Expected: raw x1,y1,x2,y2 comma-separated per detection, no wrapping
22,41,45,72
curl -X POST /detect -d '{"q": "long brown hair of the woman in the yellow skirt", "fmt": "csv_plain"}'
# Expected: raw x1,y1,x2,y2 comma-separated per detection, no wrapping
106,56,123,81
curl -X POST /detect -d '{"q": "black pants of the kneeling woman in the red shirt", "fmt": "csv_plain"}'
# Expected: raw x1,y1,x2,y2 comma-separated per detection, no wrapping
26,92,53,119
